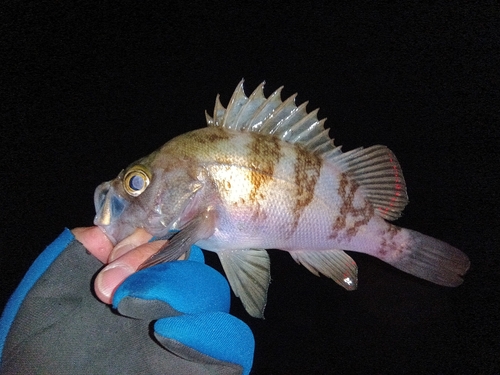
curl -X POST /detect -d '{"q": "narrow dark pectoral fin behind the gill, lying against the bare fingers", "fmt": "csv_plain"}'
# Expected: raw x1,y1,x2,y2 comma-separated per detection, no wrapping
139,210,216,270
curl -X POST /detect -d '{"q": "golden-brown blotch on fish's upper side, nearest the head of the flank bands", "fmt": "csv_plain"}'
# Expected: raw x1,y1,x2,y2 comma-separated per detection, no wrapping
248,133,282,204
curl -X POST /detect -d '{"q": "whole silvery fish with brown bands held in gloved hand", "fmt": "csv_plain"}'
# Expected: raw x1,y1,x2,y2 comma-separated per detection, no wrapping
94,80,470,318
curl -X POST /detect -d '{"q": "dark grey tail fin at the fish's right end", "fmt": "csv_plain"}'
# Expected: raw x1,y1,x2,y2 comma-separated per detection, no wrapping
384,229,470,287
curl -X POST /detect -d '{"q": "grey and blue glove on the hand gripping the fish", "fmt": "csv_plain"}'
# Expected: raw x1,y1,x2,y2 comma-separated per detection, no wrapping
0,230,254,375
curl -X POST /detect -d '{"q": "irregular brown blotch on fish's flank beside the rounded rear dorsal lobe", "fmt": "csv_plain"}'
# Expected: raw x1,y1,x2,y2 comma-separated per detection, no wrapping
330,173,374,241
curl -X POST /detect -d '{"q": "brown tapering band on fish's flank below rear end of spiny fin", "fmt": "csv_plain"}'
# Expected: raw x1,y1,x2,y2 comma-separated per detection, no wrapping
291,145,322,234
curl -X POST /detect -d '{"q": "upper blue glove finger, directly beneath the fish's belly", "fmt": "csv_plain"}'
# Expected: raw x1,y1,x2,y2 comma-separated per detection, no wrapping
113,261,230,320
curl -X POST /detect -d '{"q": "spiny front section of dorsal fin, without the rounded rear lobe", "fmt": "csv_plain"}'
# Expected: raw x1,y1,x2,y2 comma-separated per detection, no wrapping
205,80,341,156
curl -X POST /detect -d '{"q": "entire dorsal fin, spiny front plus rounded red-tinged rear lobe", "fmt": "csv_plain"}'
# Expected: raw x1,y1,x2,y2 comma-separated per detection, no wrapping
205,80,408,220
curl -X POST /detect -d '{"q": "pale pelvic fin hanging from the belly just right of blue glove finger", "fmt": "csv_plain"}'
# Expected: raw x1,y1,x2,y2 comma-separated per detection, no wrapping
218,249,271,318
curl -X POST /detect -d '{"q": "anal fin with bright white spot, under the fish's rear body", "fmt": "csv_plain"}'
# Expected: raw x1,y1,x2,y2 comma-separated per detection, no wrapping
290,250,358,290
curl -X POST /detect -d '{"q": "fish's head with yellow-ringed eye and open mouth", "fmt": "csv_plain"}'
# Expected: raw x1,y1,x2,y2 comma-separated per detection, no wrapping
94,158,203,244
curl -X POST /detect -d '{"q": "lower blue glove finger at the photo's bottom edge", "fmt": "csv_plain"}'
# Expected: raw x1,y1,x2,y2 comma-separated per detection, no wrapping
154,312,255,374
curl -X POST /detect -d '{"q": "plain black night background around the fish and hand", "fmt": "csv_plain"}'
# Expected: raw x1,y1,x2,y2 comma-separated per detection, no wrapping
0,1,500,374
